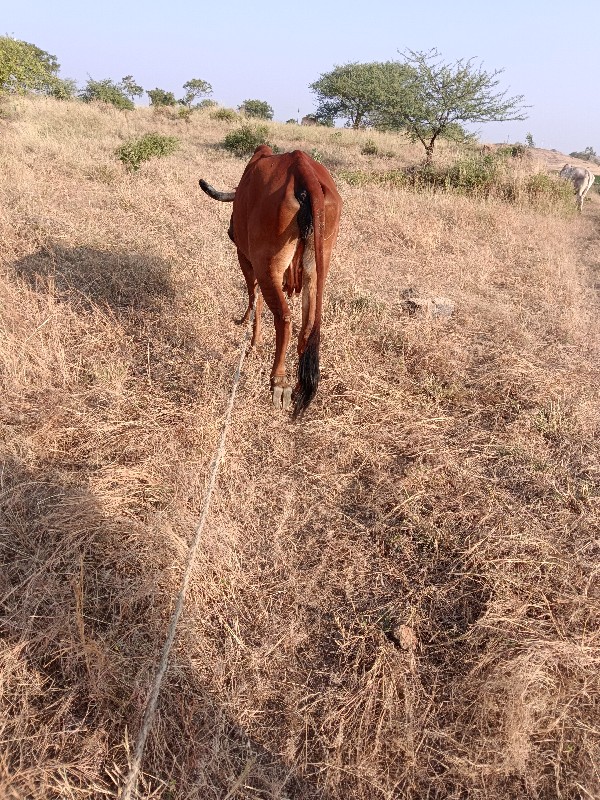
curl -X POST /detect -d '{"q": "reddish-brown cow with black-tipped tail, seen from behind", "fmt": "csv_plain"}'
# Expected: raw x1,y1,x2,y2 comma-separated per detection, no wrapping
200,145,342,417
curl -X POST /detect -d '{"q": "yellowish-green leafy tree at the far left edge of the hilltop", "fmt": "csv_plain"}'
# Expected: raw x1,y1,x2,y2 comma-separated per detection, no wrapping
0,36,60,94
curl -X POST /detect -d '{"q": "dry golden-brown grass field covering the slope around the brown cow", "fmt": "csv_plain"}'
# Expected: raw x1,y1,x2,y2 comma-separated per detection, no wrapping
0,99,600,800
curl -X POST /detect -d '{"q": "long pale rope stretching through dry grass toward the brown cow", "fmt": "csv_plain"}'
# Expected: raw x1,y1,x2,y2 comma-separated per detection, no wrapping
119,301,256,800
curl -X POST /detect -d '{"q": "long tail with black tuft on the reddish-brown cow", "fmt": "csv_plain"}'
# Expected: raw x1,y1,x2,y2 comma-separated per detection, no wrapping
293,152,326,419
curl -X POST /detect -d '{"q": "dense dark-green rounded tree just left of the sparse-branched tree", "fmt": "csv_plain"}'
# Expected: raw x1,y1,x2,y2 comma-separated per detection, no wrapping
309,61,410,129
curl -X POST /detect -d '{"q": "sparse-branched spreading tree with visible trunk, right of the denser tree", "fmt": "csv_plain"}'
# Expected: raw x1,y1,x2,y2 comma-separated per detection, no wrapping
379,50,527,163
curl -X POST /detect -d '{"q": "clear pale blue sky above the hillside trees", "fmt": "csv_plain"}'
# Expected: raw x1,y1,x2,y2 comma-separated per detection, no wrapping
5,0,600,153
